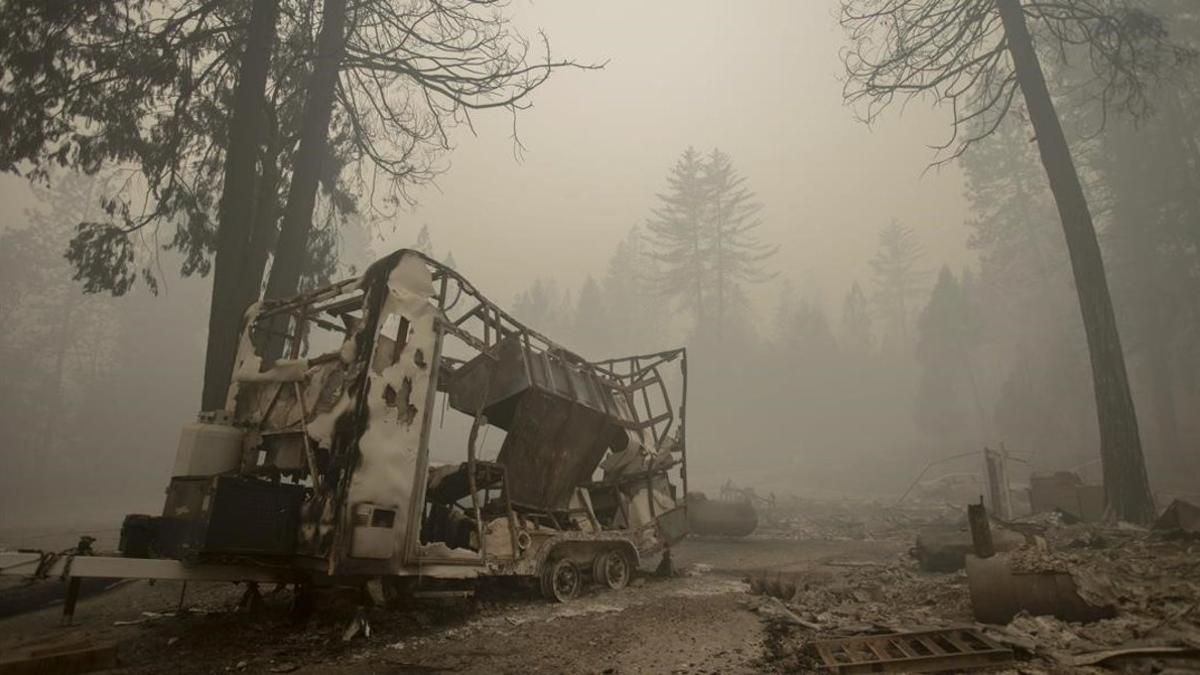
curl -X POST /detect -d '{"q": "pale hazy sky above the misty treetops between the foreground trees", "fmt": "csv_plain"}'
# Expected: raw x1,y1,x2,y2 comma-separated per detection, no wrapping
0,0,966,309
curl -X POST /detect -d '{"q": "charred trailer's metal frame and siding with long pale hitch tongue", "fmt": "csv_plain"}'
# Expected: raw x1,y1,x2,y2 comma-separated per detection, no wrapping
0,250,688,619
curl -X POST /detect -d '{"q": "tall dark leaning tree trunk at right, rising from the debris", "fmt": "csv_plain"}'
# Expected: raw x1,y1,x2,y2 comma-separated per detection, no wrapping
996,0,1154,522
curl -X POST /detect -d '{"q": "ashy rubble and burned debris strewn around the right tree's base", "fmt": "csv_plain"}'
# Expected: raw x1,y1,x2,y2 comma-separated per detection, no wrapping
745,494,1200,673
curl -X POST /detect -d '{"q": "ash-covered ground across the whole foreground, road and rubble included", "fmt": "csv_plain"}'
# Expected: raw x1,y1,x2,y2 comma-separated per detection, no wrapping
0,500,1200,674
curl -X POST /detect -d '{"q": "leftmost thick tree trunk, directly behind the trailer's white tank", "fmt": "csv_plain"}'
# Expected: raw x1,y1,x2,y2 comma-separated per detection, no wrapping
200,0,285,411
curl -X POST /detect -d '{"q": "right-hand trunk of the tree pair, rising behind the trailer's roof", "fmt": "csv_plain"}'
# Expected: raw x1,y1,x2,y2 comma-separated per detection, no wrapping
266,0,347,307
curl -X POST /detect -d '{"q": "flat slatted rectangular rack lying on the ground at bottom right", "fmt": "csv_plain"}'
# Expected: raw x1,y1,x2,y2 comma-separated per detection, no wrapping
812,627,1013,674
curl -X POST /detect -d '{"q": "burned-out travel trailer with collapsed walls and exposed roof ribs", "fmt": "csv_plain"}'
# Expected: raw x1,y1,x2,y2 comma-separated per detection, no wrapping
0,250,688,610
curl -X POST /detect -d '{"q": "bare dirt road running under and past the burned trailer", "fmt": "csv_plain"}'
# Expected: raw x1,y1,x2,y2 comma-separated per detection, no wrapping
0,537,898,674
